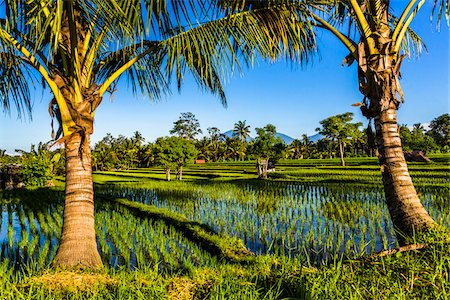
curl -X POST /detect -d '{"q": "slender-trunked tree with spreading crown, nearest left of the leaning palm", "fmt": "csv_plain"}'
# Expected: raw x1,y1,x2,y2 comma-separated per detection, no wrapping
316,112,362,166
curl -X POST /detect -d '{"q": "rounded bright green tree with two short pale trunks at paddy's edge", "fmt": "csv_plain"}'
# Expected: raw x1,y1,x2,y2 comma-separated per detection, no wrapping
153,136,197,181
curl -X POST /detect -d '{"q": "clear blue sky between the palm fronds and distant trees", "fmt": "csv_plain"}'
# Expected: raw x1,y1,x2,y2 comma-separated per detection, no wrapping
0,4,450,153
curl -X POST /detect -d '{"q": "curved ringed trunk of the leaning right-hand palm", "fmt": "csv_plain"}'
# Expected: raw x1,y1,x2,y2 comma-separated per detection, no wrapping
375,104,436,241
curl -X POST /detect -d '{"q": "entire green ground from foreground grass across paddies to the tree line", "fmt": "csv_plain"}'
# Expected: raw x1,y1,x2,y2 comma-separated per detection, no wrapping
0,155,450,299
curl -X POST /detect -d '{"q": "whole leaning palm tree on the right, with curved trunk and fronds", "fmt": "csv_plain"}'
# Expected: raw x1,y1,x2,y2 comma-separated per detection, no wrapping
234,0,450,236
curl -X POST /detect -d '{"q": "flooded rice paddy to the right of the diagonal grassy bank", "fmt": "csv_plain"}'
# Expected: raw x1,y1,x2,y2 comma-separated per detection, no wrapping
99,181,450,265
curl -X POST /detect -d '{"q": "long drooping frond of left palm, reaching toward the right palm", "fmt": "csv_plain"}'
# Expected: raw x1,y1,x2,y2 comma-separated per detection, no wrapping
161,2,316,102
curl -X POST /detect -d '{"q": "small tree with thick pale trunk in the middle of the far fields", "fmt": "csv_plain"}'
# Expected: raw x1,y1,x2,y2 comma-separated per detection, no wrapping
252,124,286,179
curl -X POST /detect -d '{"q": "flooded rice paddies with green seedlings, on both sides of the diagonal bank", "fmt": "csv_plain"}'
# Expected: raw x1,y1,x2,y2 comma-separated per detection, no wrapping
0,181,450,271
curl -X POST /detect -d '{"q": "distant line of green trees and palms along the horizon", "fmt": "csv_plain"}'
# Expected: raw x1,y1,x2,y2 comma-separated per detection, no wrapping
0,112,450,186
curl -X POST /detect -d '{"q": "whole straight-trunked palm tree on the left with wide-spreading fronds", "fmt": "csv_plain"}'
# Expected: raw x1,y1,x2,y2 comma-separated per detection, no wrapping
0,0,315,268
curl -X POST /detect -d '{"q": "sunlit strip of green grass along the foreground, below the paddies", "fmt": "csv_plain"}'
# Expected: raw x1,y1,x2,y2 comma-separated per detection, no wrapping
0,234,450,300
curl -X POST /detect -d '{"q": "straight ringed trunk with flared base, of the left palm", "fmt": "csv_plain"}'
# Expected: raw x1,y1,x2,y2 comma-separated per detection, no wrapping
53,133,102,268
